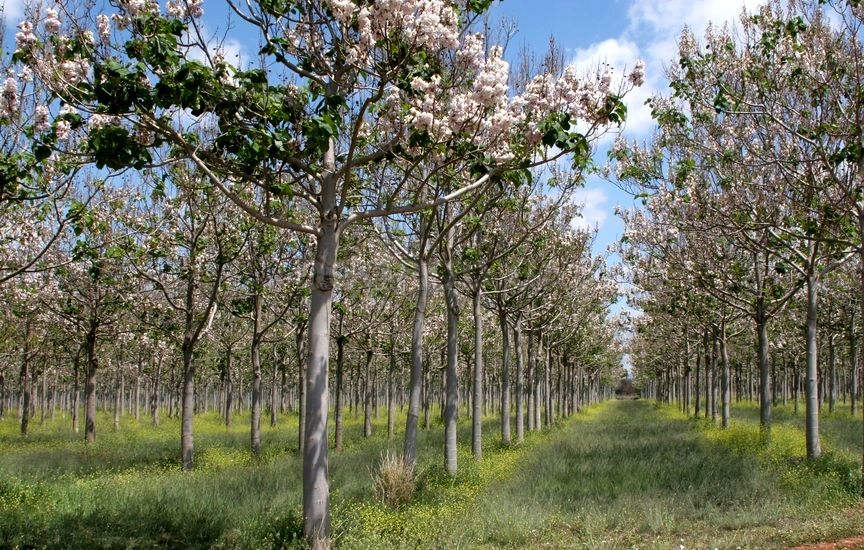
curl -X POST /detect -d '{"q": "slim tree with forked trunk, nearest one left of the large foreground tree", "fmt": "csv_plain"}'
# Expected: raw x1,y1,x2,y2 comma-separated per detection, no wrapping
130,164,245,470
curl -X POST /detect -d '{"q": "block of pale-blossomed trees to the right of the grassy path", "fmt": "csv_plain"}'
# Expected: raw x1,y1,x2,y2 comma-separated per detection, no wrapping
609,0,864,488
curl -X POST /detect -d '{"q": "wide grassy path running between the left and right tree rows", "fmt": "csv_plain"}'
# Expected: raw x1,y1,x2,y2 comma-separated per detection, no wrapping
432,401,864,548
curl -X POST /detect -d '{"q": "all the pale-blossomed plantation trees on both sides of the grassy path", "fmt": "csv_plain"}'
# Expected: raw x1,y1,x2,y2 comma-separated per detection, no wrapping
0,0,864,547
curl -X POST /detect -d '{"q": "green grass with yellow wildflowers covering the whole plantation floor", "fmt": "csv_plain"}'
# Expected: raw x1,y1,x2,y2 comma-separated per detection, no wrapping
0,401,864,549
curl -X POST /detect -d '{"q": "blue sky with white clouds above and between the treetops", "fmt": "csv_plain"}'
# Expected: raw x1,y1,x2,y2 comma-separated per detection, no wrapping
0,0,764,252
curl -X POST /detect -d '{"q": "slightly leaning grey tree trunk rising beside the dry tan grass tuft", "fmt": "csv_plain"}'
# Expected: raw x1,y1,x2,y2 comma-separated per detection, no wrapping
404,253,429,468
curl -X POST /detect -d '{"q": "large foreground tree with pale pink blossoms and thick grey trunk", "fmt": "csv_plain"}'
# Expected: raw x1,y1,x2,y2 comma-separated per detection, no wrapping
16,0,642,540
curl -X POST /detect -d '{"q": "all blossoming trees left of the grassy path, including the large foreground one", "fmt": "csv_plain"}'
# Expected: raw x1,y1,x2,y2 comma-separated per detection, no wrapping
0,0,645,546
